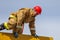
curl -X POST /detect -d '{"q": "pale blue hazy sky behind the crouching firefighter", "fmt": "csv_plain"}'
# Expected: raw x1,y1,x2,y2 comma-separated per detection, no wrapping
0,0,60,40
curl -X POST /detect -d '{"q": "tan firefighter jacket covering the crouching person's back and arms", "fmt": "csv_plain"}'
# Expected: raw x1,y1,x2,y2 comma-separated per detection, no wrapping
13,8,40,34
